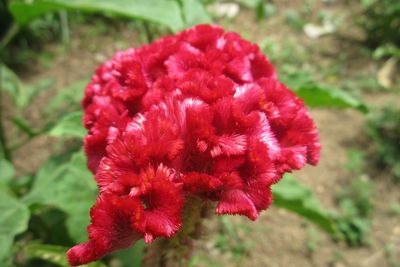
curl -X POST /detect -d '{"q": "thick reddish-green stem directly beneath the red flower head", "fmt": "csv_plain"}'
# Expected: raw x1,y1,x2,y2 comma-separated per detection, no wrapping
142,197,210,267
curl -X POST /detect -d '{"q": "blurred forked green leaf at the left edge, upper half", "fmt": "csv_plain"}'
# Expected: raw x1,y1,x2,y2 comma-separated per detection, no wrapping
0,64,53,108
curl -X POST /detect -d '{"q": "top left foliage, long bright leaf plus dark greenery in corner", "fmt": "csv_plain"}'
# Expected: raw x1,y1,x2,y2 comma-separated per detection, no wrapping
0,0,212,66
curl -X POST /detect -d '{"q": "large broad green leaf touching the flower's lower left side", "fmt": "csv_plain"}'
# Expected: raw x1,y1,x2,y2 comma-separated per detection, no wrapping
24,151,98,242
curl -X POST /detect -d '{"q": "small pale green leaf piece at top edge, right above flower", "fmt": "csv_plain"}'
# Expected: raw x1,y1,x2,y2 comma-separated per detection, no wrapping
182,0,212,27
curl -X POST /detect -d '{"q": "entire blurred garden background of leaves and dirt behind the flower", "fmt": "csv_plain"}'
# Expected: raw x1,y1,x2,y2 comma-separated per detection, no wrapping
0,0,400,267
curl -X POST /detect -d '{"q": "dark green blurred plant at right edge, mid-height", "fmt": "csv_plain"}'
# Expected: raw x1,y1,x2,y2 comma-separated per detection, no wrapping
368,106,400,182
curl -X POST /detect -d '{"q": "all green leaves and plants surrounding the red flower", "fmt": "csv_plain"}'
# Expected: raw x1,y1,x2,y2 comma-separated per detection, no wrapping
0,0,400,267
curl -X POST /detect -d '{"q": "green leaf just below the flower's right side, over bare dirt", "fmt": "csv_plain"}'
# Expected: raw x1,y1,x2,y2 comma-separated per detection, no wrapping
272,175,336,234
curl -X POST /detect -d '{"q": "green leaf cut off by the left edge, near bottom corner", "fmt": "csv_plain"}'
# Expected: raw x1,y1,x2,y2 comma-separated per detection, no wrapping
0,188,29,263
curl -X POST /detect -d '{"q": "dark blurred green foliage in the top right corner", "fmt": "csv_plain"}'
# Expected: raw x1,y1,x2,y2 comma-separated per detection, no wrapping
361,0,400,48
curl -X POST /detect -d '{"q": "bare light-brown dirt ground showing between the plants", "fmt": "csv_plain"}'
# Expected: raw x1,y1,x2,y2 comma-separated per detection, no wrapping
8,0,400,267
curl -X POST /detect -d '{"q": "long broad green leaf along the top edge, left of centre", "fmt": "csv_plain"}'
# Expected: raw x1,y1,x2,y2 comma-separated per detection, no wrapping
9,0,184,31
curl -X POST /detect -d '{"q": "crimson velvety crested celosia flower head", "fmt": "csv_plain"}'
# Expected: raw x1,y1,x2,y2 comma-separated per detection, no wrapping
68,25,320,265
